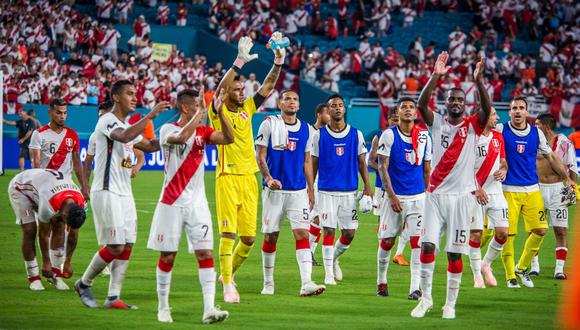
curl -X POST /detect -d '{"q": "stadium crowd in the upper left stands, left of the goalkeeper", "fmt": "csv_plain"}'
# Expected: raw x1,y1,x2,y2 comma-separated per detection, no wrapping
0,1,275,113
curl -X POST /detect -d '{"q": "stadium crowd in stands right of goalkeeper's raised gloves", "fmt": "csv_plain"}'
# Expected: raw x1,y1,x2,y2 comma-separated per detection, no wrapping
209,0,580,109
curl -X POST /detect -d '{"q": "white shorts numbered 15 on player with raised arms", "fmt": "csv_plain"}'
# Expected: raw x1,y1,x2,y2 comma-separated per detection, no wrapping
421,193,477,254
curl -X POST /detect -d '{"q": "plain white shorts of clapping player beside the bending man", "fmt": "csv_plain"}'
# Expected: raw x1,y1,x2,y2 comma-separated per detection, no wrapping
91,190,137,245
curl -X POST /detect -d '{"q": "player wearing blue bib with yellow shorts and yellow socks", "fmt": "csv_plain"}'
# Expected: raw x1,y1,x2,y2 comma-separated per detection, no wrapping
497,96,575,288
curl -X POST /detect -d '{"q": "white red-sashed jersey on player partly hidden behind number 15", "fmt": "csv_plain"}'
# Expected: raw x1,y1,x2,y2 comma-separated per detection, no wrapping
475,130,505,194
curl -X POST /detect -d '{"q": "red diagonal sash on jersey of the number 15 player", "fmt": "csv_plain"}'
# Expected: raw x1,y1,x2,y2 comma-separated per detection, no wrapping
427,118,470,192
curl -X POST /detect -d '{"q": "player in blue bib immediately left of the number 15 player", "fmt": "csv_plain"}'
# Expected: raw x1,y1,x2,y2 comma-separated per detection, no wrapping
377,97,432,300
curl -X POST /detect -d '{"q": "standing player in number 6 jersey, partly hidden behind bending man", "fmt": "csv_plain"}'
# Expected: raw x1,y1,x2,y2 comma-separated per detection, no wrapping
28,99,89,289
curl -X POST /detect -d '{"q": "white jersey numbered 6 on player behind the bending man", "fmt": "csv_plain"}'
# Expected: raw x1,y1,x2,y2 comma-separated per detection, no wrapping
28,125,79,177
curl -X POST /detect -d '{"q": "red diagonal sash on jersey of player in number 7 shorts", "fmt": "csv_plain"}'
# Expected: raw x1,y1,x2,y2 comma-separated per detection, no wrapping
161,134,205,205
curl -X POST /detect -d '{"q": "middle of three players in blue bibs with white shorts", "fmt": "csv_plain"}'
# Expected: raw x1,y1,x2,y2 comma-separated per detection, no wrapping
312,94,373,285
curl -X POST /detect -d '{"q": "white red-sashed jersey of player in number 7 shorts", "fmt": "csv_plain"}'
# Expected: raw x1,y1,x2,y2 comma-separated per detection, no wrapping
159,123,214,207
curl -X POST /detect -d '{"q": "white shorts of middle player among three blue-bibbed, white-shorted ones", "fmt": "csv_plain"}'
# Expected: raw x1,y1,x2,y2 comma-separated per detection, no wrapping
318,191,358,230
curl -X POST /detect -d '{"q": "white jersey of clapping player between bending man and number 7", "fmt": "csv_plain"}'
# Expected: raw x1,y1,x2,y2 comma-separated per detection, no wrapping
91,112,143,196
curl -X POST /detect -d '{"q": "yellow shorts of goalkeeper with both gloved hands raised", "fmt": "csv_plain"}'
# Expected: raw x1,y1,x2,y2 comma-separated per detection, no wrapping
215,174,258,236
